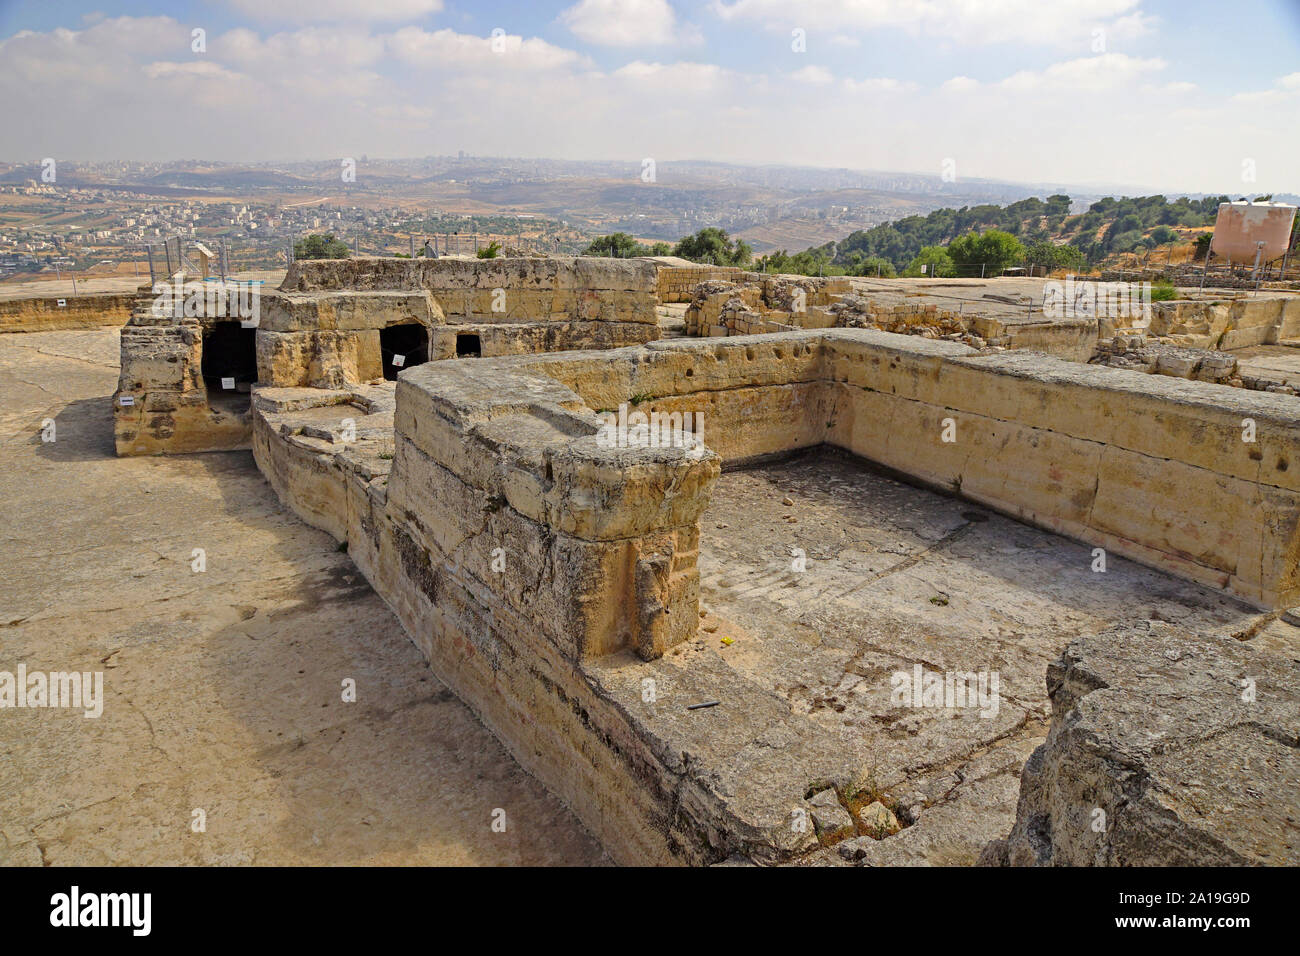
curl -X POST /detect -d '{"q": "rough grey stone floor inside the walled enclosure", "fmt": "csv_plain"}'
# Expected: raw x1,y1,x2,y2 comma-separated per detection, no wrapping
685,451,1300,865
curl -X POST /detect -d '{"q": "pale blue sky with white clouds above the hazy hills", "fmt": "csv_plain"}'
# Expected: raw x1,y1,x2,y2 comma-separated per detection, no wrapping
0,0,1300,196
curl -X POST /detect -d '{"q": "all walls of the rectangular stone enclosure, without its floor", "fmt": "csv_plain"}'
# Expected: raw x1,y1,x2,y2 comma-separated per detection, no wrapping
245,329,1300,864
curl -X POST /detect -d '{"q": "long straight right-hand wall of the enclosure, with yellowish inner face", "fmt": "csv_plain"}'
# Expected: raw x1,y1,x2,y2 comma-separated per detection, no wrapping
826,332,1300,607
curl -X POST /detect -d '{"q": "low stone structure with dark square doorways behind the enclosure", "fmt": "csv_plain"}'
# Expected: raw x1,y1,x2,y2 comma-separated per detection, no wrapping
114,258,659,454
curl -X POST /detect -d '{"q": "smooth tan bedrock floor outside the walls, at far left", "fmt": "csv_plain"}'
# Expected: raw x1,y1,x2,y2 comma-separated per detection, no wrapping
0,330,606,865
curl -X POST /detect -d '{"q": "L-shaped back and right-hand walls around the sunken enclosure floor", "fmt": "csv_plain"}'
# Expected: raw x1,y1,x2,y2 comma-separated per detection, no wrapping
504,329,1300,607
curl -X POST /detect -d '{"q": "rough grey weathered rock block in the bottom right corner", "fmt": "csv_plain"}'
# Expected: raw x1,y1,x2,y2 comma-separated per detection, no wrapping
982,620,1300,866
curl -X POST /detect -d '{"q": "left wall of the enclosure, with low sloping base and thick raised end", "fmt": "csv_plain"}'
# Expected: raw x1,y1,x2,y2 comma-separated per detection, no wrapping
254,359,725,865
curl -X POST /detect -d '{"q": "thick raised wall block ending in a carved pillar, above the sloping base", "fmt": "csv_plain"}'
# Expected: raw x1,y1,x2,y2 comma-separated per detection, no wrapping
387,360,719,658
